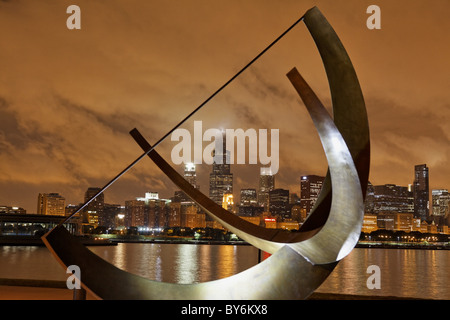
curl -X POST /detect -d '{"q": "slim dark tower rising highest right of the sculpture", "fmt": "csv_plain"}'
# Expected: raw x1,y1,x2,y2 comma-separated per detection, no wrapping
414,164,430,221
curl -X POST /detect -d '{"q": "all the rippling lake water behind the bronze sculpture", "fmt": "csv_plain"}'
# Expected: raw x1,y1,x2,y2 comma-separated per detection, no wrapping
0,243,450,299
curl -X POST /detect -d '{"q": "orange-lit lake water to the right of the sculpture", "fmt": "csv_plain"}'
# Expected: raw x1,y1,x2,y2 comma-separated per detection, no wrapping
318,248,450,299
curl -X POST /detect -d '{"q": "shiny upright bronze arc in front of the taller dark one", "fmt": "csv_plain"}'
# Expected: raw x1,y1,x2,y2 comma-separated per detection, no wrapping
287,68,364,264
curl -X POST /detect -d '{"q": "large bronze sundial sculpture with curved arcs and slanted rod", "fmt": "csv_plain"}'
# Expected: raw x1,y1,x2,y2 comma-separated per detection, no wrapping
43,8,370,300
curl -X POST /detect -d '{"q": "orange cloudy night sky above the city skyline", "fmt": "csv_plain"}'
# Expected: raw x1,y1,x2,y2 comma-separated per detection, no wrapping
0,0,450,213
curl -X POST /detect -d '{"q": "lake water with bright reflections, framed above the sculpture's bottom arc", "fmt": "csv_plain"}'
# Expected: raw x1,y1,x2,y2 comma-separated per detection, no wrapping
90,243,258,284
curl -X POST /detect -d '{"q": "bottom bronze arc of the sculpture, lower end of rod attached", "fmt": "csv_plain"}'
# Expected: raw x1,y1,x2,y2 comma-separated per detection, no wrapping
43,226,336,300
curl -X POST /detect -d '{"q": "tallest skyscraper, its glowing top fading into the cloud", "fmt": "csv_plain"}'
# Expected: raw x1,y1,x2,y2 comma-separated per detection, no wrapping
209,134,233,206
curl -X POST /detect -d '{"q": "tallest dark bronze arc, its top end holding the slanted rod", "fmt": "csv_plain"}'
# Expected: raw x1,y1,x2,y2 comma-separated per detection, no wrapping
300,7,370,231
